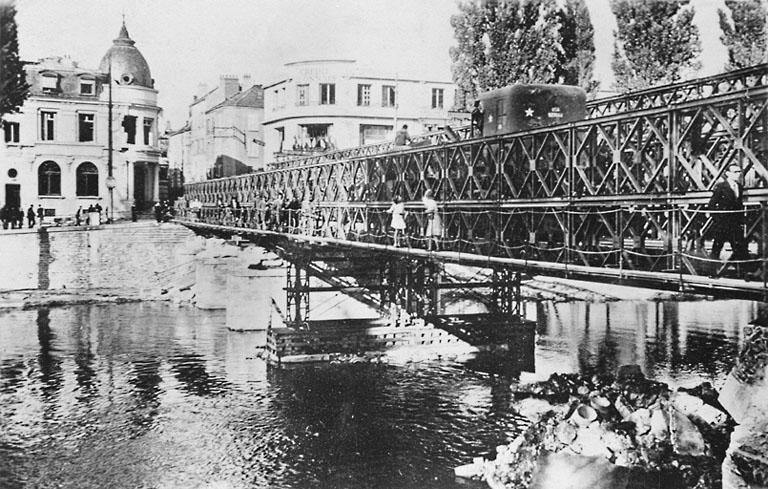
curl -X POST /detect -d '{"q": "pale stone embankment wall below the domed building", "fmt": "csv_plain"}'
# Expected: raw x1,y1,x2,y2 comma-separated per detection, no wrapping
0,222,195,291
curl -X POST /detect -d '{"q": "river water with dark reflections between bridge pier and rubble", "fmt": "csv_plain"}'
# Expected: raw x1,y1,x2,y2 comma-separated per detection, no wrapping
523,301,755,385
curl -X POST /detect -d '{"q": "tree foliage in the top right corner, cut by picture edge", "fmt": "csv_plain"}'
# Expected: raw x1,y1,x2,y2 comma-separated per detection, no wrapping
717,0,766,70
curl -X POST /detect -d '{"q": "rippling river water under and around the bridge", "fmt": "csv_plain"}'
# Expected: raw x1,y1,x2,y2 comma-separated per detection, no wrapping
0,301,755,489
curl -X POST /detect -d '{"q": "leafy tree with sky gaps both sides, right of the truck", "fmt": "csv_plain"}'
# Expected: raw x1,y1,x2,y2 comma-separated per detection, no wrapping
611,0,701,91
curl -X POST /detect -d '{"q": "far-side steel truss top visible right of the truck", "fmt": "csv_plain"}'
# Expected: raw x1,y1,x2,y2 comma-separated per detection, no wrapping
587,64,768,118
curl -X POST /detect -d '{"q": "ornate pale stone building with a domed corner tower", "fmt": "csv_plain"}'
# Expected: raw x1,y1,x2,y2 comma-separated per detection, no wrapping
0,23,162,222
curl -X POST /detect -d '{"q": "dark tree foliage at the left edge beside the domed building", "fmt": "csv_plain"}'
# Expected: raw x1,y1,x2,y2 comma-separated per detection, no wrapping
0,1,29,119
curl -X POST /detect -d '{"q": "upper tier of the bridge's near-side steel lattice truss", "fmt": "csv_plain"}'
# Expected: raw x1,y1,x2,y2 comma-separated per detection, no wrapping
186,87,768,205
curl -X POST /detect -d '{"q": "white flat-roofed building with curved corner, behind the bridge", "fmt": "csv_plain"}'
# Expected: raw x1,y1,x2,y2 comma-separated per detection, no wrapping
264,60,456,162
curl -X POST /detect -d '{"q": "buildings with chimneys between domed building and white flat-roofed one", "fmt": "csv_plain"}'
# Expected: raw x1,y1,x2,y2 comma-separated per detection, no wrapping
168,76,264,182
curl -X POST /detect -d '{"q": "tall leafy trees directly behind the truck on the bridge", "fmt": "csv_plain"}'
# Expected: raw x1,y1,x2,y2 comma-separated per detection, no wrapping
450,0,595,100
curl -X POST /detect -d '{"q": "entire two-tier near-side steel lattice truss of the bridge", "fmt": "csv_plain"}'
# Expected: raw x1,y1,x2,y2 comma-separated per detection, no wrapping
182,69,768,298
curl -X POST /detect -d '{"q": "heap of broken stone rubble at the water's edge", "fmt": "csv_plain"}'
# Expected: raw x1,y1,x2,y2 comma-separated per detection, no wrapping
464,365,733,489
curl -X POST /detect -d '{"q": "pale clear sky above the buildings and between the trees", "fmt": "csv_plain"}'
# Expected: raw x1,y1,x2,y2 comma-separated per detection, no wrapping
16,0,724,129
